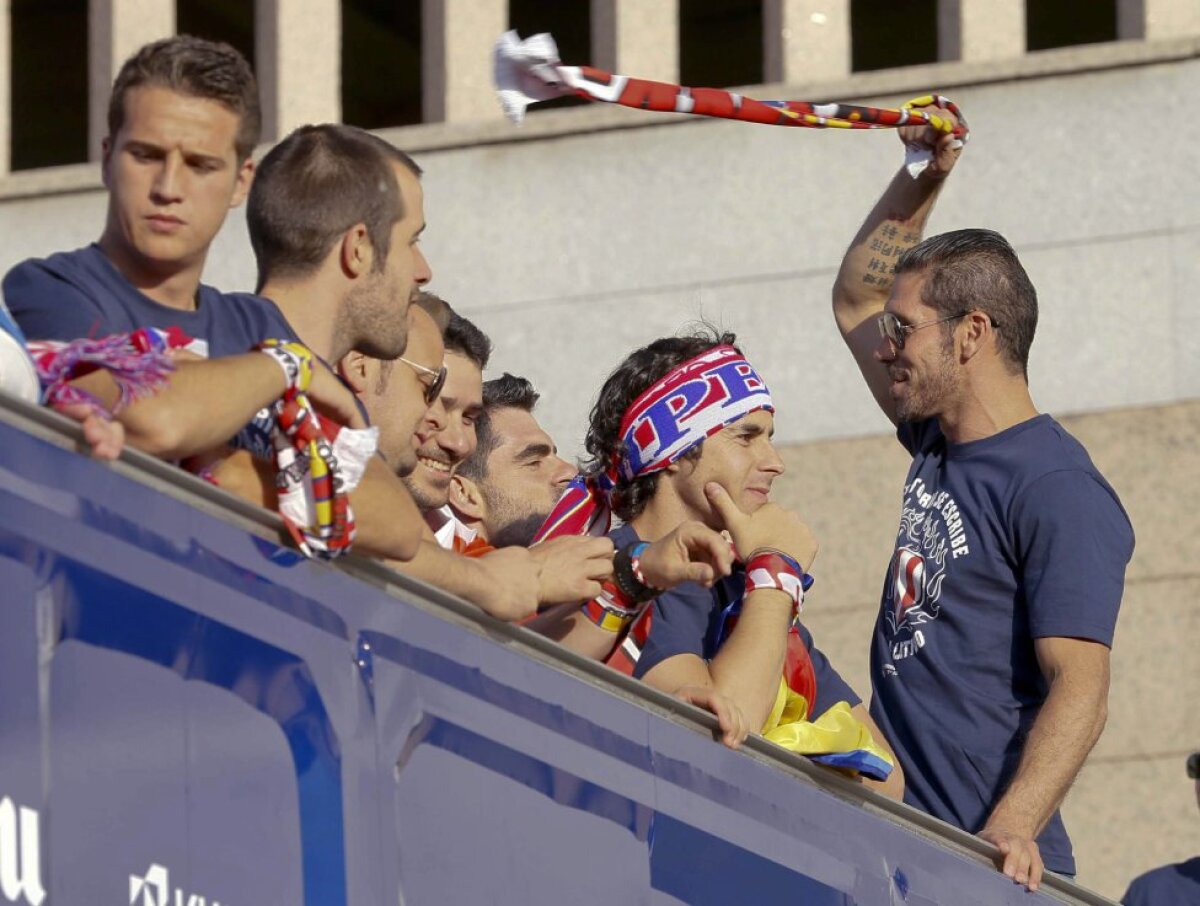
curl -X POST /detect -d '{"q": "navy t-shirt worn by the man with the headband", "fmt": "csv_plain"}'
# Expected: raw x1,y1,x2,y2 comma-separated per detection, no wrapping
608,526,863,715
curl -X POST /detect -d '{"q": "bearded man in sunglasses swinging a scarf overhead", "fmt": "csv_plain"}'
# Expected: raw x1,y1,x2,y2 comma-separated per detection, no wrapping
833,115,1133,889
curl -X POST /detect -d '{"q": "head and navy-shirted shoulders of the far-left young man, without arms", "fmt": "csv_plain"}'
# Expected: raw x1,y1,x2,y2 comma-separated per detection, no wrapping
4,35,285,356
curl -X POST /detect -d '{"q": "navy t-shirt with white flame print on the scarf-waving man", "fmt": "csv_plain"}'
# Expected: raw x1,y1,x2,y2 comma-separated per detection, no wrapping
871,415,1134,875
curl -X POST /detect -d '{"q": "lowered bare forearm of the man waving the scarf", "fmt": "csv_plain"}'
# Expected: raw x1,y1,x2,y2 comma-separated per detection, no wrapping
988,677,1108,839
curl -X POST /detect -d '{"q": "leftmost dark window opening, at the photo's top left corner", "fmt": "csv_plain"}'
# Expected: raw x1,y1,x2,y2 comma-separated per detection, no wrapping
10,0,88,170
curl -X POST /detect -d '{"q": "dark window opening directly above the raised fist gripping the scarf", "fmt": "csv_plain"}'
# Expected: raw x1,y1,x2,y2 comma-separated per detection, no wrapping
850,0,940,72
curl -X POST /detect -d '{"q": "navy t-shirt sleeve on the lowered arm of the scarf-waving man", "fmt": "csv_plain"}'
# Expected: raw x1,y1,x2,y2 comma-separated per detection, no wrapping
1013,469,1133,646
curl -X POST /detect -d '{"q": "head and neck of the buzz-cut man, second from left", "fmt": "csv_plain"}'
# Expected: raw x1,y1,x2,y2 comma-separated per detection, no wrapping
246,124,432,362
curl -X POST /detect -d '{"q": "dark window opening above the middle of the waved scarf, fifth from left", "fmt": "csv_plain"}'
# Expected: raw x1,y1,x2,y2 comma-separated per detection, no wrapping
681,0,763,88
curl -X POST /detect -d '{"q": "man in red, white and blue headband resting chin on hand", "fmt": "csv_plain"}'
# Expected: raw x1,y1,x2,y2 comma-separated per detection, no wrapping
540,334,902,796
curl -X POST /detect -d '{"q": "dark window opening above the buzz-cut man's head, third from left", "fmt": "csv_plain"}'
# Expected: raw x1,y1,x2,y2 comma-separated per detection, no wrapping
342,0,421,128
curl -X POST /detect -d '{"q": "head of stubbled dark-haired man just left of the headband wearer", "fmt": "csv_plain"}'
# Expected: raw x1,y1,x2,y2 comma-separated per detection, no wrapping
450,372,577,547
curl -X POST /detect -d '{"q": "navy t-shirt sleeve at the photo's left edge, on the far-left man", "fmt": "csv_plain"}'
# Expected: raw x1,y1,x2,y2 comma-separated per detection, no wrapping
2,260,110,340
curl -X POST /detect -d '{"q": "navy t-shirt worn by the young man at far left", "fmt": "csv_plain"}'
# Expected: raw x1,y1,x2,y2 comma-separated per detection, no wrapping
4,242,298,457
